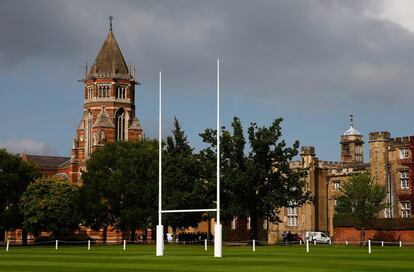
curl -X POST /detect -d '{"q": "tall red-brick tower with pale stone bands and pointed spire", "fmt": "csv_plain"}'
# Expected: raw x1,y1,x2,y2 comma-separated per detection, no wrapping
69,17,143,183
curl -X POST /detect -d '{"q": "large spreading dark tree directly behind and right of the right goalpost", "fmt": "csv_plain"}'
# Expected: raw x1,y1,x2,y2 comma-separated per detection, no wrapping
201,117,310,239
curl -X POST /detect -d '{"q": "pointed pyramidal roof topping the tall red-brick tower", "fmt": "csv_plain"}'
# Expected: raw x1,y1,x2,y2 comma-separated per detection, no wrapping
89,20,129,75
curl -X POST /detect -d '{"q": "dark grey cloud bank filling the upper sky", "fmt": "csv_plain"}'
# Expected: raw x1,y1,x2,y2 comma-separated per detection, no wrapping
0,0,414,110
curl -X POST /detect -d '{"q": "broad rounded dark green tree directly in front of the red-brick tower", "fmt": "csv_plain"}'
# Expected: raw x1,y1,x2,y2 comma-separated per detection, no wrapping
81,139,158,241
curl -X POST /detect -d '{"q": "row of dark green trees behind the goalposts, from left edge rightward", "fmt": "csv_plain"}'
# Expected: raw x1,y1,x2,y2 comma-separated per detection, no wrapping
0,118,310,242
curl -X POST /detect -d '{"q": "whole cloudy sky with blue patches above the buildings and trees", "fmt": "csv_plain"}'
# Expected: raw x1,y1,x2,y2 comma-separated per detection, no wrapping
0,0,414,160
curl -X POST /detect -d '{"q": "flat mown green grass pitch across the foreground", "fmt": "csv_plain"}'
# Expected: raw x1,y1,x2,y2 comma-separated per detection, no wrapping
0,245,414,272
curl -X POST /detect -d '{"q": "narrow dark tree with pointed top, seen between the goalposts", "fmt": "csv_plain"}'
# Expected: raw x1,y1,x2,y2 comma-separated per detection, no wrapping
162,118,204,238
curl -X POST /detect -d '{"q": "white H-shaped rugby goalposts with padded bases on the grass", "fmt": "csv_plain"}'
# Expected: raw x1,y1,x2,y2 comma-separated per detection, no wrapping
156,59,222,258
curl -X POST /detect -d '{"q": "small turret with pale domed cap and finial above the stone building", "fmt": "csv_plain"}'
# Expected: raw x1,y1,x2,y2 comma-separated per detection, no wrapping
341,114,364,163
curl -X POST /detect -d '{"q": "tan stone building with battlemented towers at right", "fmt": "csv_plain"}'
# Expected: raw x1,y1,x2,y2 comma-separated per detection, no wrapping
268,115,414,242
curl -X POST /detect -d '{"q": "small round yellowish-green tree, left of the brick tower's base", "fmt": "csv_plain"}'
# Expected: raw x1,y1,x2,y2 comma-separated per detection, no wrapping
20,177,80,238
